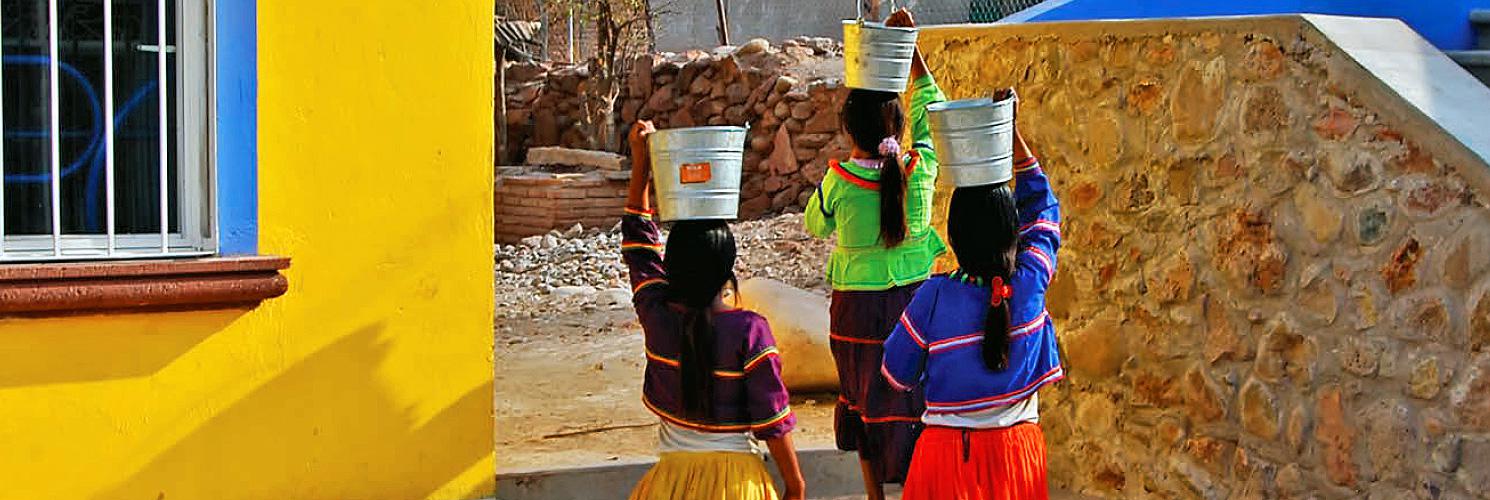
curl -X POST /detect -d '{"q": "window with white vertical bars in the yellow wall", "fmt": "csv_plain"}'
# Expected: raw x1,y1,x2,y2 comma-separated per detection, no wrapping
0,0,216,260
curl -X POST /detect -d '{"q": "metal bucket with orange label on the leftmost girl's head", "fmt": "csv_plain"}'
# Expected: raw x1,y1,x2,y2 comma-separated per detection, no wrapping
648,126,746,220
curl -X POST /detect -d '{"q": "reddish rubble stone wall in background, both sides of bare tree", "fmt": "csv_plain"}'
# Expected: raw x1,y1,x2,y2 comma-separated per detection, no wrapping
505,39,851,219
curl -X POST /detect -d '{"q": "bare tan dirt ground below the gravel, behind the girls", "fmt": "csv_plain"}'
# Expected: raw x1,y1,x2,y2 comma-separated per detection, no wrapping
496,302,833,470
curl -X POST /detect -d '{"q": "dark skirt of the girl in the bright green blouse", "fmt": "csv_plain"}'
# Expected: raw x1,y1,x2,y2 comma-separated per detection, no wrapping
828,283,925,482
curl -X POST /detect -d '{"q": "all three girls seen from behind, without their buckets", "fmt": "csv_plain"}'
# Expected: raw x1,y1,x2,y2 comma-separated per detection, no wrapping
621,10,1064,500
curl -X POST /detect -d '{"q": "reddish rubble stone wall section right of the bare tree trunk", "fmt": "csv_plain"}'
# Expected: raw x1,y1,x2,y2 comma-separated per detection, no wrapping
621,39,851,219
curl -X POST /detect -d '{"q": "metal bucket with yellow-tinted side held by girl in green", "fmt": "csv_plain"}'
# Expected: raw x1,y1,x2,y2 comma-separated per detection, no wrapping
843,19,916,92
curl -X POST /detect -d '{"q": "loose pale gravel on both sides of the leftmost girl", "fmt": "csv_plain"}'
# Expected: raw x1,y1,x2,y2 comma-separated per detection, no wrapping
495,214,833,318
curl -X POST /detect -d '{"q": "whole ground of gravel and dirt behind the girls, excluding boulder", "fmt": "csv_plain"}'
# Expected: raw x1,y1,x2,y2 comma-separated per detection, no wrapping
495,216,836,472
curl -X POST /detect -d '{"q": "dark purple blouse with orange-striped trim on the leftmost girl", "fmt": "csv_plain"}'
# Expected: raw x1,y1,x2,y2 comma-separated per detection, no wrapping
621,210,797,439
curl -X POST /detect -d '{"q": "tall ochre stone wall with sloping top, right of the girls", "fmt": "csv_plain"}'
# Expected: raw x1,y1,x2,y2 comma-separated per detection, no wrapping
922,18,1490,499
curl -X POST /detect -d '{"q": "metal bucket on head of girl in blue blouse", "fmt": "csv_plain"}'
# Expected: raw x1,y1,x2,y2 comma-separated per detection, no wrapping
927,97,1016,188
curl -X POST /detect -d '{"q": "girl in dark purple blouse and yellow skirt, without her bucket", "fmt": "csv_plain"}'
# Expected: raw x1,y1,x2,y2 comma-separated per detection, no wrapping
621,122,805,500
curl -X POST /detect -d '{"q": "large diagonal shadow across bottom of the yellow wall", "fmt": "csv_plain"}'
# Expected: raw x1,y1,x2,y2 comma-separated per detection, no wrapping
97,324,492,499
